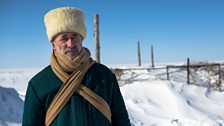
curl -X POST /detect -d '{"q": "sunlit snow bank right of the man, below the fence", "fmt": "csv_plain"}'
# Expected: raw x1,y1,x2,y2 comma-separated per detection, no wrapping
121,70,224,126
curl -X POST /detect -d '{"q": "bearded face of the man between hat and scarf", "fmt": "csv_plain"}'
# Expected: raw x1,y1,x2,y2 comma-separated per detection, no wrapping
52,32,82,60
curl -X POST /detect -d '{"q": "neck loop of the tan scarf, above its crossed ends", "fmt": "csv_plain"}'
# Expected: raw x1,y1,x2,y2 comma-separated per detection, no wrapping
50,48,94,83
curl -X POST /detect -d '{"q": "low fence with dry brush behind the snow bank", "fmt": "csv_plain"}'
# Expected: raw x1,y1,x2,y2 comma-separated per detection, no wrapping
112,60,224,91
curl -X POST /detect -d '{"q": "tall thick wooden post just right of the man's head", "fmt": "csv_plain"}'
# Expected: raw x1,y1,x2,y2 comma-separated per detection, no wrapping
94,14,100,63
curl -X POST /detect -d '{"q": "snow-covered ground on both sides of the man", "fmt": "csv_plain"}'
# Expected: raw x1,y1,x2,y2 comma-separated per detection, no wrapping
0,65,224,126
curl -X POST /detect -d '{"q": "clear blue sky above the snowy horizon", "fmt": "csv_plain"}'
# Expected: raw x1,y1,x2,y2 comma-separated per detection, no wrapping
0,0,224,68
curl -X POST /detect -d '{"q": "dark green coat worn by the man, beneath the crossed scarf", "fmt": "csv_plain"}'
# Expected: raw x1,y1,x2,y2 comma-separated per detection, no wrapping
22,63,130,126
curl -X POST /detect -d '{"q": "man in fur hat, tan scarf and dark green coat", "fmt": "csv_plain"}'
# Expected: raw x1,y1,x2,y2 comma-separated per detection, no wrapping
22,7,130,126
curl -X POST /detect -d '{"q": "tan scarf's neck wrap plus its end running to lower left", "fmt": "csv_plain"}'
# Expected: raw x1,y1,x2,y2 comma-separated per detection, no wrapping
45,48,94,125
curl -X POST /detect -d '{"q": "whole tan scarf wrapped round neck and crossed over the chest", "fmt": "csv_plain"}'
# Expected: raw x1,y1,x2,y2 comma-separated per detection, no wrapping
45,48,111,126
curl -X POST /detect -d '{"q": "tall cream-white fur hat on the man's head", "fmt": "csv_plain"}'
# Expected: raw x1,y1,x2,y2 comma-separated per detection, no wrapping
44,7,86,42
